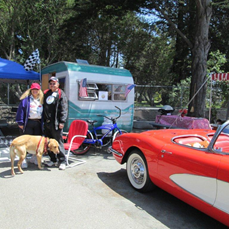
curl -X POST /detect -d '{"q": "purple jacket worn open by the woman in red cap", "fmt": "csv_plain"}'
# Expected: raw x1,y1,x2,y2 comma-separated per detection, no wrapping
16,96,43,132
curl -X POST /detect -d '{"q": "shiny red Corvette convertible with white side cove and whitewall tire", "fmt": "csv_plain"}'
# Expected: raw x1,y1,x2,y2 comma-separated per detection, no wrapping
109,121,229,226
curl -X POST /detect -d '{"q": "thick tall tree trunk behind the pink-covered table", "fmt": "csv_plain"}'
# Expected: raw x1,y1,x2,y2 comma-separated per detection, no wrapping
189,0,212,117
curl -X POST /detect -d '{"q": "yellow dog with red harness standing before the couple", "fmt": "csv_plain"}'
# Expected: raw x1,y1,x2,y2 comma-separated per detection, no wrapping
10,135,59,176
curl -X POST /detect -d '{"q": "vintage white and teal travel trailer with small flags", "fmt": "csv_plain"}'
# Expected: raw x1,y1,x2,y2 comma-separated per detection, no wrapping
41,61,134,132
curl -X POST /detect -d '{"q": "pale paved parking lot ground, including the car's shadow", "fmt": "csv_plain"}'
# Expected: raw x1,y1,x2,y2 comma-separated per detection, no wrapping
0,142,227,229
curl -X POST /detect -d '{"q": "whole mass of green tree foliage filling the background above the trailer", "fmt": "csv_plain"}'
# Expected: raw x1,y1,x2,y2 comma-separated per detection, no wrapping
0,0,229,112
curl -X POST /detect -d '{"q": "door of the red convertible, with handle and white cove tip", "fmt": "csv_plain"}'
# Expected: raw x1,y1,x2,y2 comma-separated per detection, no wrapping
158,143,220,205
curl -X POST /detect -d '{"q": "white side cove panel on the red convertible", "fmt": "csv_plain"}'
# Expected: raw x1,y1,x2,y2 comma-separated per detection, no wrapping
170,174,229,214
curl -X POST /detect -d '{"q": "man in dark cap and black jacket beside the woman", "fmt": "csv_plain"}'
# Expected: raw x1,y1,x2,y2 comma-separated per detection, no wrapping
43,76,68,170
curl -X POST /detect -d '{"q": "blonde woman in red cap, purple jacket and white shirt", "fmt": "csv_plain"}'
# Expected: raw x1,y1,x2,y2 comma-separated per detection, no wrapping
16,83,44,167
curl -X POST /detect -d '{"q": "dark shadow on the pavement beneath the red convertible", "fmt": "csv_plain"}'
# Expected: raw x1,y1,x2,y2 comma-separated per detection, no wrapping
98,169,227,229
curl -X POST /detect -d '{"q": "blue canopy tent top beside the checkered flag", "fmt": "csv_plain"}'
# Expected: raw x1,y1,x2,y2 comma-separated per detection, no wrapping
0,58,40,83
